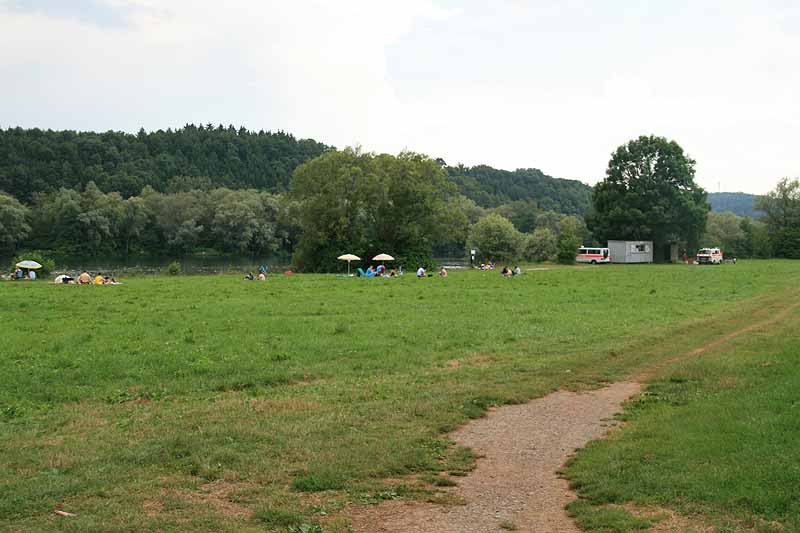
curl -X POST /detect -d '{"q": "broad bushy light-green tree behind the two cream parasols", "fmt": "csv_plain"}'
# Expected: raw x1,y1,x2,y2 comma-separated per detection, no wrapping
291,148,456,271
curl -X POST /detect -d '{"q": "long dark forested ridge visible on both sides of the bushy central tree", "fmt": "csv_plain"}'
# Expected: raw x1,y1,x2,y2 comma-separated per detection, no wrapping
0,124,591,215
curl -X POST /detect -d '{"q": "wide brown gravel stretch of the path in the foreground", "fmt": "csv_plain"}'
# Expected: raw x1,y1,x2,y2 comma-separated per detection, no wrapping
351,382,640,533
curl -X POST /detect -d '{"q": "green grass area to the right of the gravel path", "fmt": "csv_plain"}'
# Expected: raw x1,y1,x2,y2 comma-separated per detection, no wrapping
566,302,800,531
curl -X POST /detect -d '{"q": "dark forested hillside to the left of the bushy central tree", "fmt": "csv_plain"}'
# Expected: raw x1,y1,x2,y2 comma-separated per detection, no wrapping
0,124,329,202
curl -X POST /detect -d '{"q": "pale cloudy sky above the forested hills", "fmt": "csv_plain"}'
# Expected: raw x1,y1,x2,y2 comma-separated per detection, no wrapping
0,0,800,194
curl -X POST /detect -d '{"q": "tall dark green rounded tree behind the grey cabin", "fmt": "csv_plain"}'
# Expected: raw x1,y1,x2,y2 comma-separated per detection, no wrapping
587,136,710,260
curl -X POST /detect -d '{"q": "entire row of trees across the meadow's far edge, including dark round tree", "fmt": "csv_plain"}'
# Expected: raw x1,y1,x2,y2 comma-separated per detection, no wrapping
0,127,800,271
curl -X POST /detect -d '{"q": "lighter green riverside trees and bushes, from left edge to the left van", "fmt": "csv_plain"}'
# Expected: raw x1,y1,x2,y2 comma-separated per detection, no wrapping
0,148,600,271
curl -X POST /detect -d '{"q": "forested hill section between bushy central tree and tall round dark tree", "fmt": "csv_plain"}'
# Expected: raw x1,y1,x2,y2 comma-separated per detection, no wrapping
447,165,592,215
